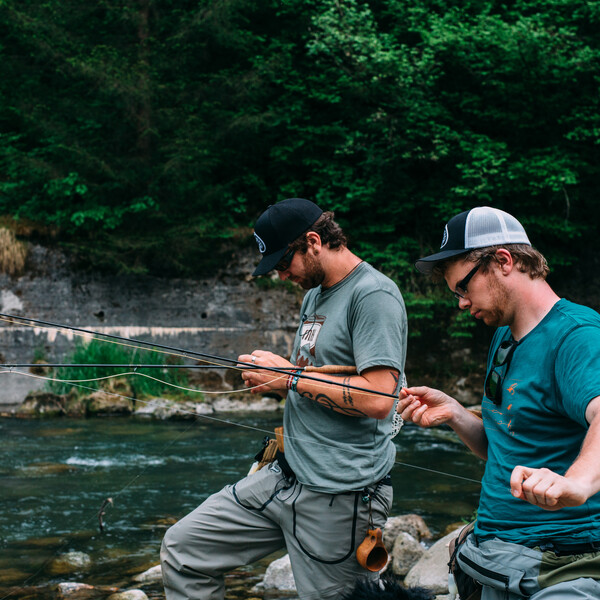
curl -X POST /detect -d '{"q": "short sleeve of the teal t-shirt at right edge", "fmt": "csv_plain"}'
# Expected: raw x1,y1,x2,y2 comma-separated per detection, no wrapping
555,325,600,427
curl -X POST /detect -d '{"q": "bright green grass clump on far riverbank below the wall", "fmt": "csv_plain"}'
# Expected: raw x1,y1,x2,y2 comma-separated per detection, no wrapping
47,340,190,398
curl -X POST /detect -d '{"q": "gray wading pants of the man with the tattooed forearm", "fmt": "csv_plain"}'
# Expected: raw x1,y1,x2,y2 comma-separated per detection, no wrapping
160,461,392,600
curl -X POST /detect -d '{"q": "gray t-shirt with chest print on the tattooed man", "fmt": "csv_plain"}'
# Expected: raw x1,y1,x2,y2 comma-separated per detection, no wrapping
284,262,407,493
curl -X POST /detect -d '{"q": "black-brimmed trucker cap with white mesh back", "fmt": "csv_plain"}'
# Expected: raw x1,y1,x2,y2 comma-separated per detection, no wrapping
415,206,531,274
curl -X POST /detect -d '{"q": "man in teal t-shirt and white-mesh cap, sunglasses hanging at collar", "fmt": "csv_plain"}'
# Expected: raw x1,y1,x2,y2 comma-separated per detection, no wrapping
398,207,600,600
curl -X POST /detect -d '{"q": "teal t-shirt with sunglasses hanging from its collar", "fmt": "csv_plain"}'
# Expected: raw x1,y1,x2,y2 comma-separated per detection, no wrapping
475,299,600,546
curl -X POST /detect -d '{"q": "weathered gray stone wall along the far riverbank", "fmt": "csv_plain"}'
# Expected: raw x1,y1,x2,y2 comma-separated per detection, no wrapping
0,246,301,403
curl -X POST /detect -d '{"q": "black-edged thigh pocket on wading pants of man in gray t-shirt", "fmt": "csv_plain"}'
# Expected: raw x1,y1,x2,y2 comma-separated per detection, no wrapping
293,488,362,565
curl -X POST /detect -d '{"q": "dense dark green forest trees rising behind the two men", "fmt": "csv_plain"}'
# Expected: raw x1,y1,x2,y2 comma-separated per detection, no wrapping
0,0,600,336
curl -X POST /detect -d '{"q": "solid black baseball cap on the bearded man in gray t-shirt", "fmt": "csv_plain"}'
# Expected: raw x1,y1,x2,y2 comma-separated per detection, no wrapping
252,198,323,277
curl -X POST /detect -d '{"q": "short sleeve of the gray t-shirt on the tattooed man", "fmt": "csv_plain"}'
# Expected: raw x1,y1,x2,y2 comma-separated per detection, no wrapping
350,290,407,373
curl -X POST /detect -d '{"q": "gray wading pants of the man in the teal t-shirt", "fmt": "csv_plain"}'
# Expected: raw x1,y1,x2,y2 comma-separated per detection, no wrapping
457,534,600,600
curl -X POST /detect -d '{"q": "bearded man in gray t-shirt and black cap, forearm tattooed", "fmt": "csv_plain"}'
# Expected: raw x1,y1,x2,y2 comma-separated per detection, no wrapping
161,198,407,600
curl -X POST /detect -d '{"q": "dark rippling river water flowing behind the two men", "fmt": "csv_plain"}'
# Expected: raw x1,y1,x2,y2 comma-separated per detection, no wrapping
0,413,483,598
